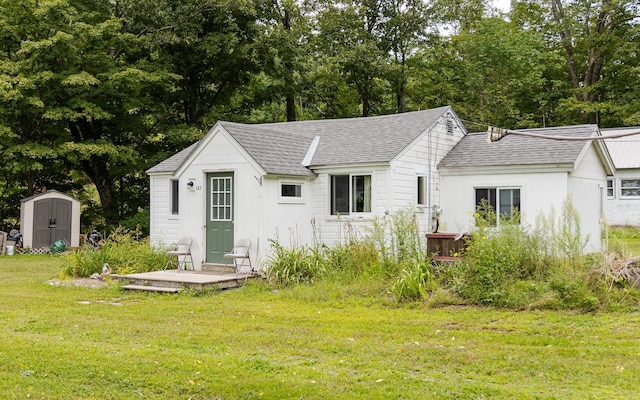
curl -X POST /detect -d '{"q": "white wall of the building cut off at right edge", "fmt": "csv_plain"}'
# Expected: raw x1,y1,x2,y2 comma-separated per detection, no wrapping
605,168,640,226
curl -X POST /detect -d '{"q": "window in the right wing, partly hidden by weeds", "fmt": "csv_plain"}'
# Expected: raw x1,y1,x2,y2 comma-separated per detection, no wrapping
475,187,520,225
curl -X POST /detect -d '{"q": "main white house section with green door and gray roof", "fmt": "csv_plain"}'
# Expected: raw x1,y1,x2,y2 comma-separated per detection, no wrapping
147,107,466,269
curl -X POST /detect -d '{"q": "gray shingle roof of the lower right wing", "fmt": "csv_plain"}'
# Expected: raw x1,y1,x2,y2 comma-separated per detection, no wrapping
438,125,598,168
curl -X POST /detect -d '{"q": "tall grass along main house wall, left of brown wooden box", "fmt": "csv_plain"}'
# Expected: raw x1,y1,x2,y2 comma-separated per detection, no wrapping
265,210,428,298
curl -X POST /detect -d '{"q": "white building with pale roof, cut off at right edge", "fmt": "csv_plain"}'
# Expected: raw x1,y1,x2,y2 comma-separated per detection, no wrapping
602,126,640,226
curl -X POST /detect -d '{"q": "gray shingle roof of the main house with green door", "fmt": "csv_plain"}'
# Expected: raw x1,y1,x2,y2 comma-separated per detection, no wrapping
147,106,452,176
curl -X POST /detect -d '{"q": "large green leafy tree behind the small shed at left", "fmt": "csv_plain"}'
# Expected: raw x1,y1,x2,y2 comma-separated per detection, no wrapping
0,0,176,225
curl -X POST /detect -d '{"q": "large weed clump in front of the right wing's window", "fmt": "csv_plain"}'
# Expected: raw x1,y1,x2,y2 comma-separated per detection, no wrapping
446,198,637,311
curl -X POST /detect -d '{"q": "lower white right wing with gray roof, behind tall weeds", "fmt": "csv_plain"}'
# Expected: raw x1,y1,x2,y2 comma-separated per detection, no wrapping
438,125,615,251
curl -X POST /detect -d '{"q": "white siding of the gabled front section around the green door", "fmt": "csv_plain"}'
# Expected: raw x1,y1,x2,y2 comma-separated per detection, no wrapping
156,129,314,269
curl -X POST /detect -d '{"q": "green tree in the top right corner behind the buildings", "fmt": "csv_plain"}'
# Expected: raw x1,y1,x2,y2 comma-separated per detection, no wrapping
513,0,640,125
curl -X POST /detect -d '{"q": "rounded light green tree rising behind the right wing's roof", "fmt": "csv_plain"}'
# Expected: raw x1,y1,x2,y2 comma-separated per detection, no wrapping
410,17,567,129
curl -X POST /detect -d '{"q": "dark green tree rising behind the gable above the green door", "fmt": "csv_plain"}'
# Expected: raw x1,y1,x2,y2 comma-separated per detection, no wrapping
119,0,262,126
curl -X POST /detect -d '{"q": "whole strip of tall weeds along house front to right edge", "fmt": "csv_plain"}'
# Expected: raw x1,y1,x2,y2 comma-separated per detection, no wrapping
265,202,640,311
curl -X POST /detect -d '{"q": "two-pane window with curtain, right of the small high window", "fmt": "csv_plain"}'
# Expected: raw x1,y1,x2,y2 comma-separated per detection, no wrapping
331,174,371,215
